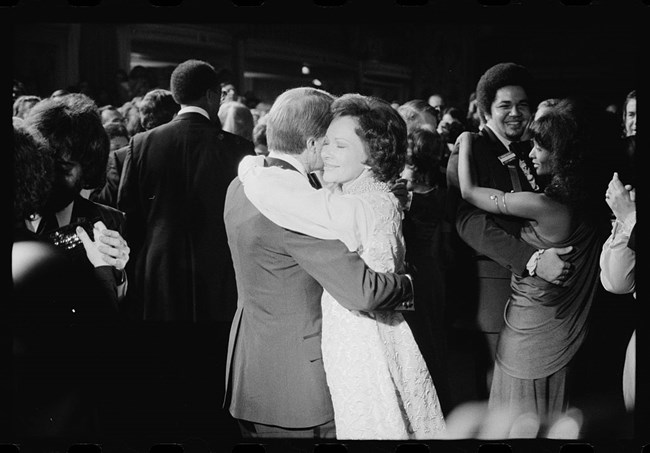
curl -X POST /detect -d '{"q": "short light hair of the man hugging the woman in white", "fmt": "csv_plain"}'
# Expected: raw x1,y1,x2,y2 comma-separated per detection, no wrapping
266,87,334,154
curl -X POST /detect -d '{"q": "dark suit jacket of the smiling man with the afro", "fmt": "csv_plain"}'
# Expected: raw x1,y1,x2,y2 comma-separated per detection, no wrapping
447,127,536,332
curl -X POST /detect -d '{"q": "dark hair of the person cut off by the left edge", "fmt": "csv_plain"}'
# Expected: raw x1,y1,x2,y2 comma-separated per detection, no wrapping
13,121,54,221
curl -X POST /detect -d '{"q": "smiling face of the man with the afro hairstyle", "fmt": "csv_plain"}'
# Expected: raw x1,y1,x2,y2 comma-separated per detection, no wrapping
486,85,531,141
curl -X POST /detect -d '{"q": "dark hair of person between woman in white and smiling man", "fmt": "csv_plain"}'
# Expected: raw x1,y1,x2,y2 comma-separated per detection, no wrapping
406,128,446,186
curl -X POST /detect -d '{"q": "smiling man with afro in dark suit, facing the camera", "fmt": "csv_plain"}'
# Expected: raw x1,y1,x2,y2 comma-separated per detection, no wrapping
447,63,571,399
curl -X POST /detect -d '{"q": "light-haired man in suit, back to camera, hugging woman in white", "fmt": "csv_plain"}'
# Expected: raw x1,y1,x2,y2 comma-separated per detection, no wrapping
224,88,412,438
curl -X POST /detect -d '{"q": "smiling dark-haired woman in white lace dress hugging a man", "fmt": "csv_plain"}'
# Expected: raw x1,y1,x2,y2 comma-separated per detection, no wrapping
239,94,445,439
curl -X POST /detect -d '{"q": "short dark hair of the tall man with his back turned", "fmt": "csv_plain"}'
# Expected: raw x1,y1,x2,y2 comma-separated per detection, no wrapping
169,60,221,104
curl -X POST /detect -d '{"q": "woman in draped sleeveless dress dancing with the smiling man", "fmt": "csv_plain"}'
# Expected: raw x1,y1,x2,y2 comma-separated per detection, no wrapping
458,100,616,424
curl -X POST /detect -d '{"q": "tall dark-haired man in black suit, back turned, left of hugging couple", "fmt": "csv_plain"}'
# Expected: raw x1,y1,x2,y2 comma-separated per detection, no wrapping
118,60,254,441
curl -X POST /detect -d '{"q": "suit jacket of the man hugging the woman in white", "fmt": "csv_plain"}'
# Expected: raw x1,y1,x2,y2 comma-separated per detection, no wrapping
224,162,411,428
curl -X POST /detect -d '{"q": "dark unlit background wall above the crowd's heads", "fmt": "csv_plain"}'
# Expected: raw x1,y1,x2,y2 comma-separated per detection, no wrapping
13,20,638,114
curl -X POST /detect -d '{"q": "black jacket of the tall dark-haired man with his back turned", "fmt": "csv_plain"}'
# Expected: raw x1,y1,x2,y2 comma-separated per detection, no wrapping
118,113,254,323
